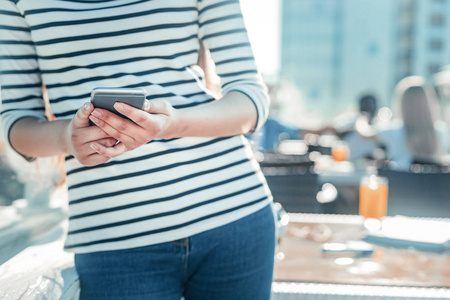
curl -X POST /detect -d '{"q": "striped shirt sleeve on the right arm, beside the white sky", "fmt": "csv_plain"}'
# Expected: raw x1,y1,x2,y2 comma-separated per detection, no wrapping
198,0,270,129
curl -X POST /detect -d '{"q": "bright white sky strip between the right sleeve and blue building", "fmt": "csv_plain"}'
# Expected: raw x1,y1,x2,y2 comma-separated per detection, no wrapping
241,0,280,77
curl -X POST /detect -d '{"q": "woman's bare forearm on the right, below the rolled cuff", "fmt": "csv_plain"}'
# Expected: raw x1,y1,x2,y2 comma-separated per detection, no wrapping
175,92,257,137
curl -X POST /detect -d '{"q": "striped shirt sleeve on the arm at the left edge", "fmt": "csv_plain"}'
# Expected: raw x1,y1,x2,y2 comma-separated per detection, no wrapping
0,0,46,151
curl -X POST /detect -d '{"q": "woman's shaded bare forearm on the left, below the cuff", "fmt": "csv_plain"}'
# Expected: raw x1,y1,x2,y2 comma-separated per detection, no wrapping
9,118,70,157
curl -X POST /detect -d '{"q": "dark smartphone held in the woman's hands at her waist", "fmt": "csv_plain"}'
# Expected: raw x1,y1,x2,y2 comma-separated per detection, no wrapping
91,87,147,120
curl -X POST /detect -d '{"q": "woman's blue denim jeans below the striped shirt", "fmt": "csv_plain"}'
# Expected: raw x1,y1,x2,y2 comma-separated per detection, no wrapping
75,205,275,300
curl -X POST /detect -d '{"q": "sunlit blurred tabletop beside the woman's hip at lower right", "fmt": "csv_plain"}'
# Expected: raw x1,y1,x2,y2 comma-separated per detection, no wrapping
273,214,450,300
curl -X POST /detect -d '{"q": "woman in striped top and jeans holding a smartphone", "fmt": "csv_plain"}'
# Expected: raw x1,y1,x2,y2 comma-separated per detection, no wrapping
0,0,275,300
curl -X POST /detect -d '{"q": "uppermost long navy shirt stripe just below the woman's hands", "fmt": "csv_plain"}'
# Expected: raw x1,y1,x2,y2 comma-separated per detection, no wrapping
67,137,232,176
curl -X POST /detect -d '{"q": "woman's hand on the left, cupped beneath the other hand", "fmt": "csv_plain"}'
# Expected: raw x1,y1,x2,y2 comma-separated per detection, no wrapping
64,102,117,166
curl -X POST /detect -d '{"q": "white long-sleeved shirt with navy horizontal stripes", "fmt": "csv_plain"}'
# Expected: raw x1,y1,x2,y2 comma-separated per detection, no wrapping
0,0,271,253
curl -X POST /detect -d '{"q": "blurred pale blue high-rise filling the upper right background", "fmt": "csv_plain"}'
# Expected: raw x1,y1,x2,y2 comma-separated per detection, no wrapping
280,0,450,116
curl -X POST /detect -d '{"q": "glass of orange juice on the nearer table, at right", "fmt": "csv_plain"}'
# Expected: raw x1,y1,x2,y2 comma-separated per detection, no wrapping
359,175,388,229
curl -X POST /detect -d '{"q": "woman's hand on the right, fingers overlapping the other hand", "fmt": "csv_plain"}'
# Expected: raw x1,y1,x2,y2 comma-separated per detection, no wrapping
89,100,177,157
